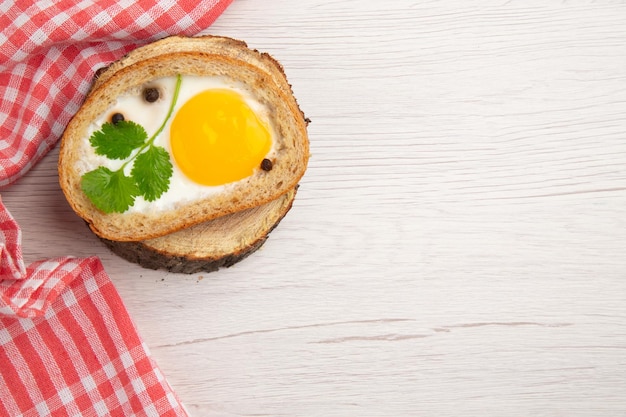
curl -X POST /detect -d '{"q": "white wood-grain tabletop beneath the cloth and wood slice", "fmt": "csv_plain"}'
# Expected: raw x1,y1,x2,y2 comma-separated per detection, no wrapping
2,0,626,417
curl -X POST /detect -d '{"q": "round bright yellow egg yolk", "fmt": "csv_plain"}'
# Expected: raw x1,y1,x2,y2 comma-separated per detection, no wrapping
170,89,272,185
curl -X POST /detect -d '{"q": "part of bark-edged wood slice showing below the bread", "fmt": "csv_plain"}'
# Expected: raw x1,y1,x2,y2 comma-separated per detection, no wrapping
100,187,297,274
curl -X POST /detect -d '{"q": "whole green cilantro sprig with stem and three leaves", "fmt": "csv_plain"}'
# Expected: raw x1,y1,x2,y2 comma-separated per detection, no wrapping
80,75,181,213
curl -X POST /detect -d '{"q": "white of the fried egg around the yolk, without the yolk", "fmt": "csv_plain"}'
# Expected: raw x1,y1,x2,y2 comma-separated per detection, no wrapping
77,75,276,213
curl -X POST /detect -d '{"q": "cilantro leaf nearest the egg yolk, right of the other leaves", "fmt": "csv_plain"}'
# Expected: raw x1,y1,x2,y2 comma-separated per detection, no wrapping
130,146,174,201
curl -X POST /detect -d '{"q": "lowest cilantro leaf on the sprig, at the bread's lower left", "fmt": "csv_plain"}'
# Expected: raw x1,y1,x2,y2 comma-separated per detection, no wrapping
80,166,139,213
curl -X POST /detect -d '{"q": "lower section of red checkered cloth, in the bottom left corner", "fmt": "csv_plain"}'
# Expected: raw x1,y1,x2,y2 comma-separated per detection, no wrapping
0,200,187,417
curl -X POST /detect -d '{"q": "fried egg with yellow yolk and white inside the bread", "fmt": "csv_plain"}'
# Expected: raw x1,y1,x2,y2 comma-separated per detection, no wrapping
80,75,276,213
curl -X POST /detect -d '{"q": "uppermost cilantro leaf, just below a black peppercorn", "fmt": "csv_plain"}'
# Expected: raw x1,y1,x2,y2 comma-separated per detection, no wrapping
89,120,148,159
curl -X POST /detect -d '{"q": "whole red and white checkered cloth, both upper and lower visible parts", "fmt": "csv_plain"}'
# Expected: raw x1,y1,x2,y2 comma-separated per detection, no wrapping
0,0,232,416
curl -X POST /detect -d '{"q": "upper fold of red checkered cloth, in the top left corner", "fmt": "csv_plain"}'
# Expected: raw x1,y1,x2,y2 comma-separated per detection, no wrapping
0,0,232,187
